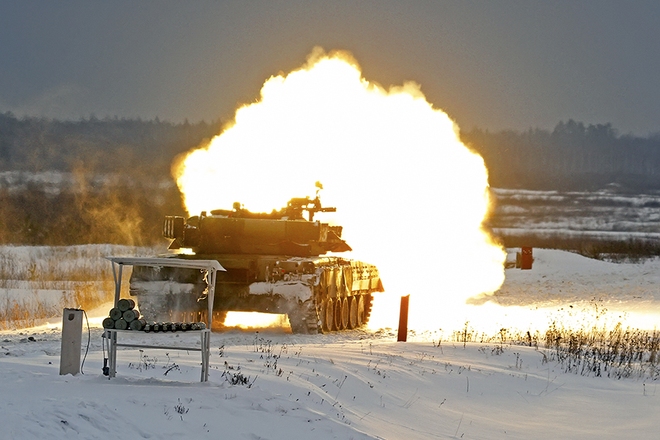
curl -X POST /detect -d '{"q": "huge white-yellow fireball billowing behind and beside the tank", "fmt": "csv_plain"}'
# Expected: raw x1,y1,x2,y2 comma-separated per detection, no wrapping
175,48,505,329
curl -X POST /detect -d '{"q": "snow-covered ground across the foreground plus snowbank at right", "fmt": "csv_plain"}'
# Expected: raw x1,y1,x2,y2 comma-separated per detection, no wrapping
0,249,660,440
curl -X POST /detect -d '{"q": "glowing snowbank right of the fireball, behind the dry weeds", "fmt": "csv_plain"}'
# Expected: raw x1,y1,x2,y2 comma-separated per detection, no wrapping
468,249,660,331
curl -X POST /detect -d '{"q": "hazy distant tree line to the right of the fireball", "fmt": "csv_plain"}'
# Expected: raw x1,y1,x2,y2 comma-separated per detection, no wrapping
461,120,660,192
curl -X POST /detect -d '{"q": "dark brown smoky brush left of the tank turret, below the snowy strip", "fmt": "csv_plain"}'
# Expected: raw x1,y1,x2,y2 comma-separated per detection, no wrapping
0,175,183,246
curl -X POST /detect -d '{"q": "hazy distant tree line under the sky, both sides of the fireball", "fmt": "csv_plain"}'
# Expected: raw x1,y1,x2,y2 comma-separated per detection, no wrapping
0,113,660,190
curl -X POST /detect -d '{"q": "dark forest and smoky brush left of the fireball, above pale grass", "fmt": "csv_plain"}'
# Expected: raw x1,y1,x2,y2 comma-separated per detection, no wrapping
0,113,221,245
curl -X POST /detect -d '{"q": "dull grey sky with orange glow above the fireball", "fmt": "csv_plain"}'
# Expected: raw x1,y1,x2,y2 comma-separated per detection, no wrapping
0,0,660,136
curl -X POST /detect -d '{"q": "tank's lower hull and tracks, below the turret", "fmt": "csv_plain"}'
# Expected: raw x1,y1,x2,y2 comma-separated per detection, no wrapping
130,254,383,333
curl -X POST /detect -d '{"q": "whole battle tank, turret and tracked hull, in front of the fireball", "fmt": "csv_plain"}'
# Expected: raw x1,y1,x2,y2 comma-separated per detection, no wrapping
130,193,383,333
